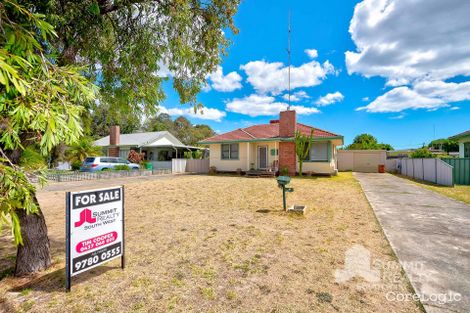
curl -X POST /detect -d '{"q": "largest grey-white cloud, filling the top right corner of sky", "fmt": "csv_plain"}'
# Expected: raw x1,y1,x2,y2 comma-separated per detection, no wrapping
346,0,470,86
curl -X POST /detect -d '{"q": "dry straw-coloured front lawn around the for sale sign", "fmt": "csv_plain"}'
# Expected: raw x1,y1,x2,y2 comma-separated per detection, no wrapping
0,173,420,312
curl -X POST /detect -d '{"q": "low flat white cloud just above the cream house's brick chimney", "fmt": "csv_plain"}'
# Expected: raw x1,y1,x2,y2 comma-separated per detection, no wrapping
226,94,320,117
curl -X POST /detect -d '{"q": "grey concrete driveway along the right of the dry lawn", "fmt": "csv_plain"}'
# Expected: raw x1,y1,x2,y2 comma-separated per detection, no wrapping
354,173,470,313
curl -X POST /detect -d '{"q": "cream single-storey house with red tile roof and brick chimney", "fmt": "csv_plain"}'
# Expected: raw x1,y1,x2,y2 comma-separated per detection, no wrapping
199,110,343,175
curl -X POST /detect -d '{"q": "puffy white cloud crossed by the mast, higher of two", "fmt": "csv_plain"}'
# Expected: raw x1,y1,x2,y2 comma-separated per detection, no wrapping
240,61,335,95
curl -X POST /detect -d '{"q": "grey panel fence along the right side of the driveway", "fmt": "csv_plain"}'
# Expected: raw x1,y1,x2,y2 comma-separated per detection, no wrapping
396,158,454,186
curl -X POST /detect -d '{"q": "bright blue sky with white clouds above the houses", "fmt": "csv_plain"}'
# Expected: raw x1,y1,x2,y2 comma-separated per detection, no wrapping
159,0,470,149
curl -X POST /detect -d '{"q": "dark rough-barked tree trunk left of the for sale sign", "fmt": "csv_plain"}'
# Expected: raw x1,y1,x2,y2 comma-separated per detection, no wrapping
15,197,51,276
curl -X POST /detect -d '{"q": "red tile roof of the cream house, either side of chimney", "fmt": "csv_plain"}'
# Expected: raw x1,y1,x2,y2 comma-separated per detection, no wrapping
200,120,339,143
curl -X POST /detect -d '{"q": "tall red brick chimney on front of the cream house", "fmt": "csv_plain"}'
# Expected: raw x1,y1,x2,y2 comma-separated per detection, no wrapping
279,110,297,176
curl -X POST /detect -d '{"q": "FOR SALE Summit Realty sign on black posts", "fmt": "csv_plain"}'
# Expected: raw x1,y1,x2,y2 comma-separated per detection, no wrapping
66,186,124,290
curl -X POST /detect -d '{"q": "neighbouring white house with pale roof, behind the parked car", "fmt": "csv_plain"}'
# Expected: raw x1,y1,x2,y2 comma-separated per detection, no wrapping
94,126,201,168
